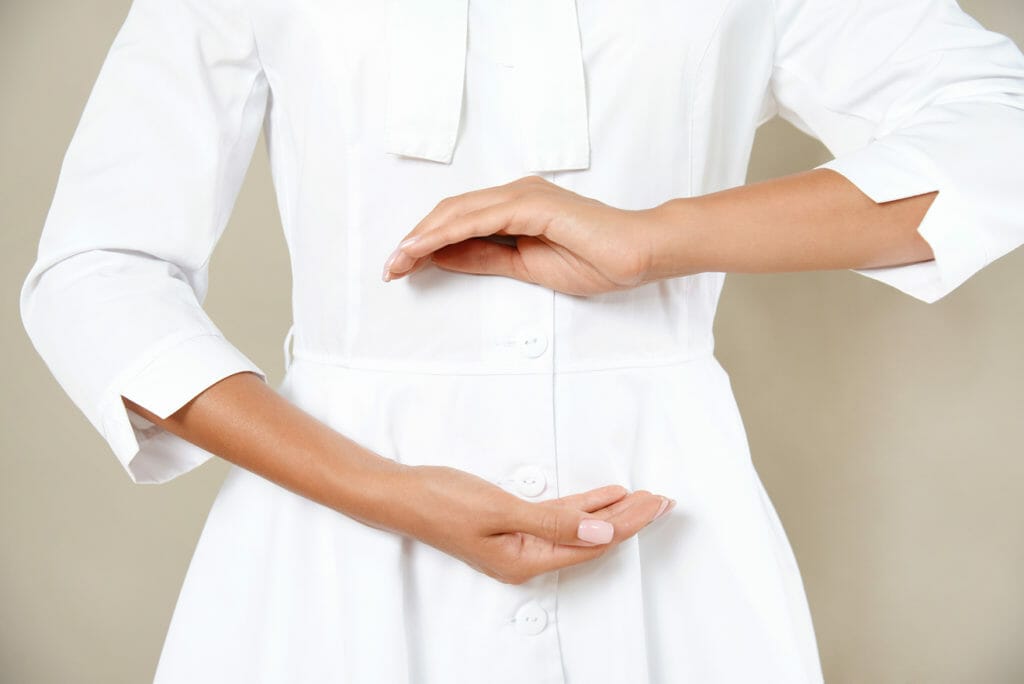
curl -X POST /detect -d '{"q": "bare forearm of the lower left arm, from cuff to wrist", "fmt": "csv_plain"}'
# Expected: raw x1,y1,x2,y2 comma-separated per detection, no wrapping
122,373,403,526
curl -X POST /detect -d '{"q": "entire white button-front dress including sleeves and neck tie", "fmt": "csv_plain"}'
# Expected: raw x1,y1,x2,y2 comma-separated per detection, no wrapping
22,0,1024,684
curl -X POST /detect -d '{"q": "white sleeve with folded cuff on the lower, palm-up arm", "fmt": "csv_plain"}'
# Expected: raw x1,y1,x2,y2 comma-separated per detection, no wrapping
20,0,268,483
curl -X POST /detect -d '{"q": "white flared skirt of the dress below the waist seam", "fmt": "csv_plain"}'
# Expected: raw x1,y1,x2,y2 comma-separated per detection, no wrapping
155,353,822,684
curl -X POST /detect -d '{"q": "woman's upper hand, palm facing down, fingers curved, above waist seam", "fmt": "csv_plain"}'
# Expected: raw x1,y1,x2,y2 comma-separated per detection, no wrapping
383,176,653,295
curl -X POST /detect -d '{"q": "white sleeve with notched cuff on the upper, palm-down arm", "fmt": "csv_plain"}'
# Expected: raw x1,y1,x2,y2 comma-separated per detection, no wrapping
771,0,1024,302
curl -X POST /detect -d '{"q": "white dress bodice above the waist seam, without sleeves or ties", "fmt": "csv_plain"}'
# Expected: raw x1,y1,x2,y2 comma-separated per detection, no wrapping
250,0,773,372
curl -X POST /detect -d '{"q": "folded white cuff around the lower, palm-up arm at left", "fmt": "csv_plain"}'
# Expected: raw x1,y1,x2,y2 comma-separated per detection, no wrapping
100,333,266,484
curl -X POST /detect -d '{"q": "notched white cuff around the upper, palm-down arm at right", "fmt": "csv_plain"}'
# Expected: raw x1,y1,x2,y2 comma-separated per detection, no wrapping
815,139,991,303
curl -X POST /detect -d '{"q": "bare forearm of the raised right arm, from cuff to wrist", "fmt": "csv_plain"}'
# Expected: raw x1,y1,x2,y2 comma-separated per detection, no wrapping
644,169,936,281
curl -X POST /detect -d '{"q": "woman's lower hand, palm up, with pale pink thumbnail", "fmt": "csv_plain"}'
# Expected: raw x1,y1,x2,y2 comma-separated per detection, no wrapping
364,465,675,584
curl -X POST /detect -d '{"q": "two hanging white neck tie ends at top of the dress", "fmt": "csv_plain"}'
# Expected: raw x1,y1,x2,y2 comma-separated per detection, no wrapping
384,0,590,172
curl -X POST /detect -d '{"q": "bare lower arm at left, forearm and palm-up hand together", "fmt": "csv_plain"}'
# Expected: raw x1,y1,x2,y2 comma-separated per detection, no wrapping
122,372,674,584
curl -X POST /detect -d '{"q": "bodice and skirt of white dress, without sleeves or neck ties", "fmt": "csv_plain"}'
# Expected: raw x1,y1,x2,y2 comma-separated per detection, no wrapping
157,0,820,684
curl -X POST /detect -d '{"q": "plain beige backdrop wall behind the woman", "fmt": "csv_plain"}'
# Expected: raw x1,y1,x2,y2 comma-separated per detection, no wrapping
0,0,1024,683
